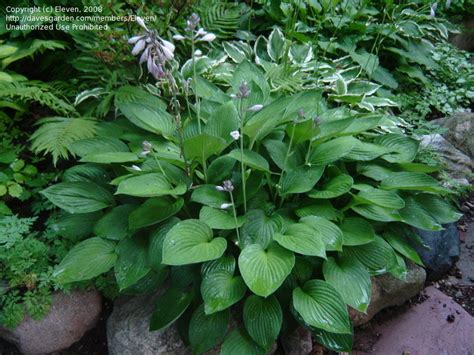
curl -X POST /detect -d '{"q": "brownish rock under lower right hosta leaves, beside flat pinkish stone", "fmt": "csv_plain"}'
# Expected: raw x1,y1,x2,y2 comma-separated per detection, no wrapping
349,264,426,327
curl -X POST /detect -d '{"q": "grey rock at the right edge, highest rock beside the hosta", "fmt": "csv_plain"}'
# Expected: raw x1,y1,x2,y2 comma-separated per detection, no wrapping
433,112,474,158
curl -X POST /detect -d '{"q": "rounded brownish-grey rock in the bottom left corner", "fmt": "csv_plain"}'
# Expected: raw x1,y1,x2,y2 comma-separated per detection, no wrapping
0,290,102,354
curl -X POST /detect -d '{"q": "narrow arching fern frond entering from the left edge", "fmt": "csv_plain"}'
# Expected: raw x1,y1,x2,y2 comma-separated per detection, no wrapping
0,82,76,115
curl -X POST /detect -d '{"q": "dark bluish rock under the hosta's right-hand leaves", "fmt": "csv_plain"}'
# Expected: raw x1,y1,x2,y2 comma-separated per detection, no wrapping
415,223,460,280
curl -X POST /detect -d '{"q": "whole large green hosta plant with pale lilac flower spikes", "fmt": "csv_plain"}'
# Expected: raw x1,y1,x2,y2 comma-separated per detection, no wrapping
42,15,459,354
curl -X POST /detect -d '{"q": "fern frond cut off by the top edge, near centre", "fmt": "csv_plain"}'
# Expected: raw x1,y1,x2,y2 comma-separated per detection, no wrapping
197,1,248,38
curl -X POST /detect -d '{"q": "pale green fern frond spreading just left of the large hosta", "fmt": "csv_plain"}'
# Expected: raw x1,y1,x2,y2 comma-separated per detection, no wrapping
30,117,97,165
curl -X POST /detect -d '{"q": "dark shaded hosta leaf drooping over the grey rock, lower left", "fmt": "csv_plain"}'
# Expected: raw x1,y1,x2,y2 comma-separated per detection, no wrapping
150,288,193,331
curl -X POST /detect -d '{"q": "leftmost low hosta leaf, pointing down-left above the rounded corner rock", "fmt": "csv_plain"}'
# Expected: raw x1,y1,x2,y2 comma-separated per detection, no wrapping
53,237,117,283
